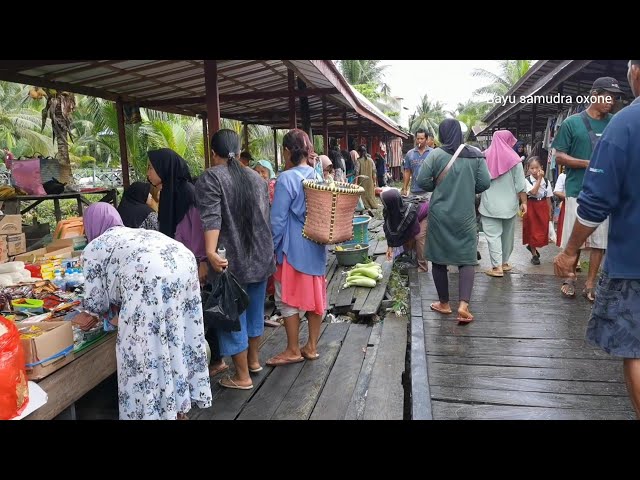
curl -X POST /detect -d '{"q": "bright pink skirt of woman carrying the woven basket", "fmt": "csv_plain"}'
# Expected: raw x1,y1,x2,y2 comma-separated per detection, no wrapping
273,255,327,315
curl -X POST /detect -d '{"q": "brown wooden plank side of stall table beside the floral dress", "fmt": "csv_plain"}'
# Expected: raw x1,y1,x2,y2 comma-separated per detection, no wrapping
24,332,117,420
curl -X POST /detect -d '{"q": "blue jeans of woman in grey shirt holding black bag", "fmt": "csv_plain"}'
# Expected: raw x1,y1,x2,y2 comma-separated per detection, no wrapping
218,280,267,356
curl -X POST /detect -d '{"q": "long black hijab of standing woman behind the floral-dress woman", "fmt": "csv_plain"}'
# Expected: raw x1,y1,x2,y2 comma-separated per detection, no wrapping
147,148,196,238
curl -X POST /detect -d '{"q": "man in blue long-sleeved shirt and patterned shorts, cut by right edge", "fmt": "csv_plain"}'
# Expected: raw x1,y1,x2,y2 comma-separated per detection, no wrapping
554,60,640,419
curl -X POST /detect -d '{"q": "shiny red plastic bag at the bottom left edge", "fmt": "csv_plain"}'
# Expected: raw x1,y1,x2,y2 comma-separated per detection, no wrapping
0,316,29,420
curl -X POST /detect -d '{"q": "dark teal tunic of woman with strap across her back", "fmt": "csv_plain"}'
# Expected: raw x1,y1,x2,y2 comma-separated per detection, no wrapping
418,148,491,266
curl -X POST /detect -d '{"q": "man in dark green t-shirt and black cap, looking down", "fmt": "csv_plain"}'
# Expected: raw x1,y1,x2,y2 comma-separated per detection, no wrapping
552,77,622,302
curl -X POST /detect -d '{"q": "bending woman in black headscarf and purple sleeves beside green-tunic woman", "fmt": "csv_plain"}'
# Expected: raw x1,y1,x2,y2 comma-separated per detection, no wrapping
380,188,429,260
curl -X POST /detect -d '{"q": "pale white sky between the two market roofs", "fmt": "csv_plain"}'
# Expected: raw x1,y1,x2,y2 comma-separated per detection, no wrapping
382,60,499,124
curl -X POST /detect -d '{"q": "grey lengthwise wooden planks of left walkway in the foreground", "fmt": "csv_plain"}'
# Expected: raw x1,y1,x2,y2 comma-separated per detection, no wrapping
189,316,407,420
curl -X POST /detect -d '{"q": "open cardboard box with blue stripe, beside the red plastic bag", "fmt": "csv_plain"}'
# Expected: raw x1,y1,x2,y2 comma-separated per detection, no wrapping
18,322,74,380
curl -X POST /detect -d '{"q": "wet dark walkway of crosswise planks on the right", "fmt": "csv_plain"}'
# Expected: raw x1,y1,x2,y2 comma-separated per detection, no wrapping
411,273,635,420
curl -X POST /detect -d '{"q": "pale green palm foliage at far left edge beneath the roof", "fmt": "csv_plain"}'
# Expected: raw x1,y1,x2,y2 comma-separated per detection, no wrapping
0,81,53,157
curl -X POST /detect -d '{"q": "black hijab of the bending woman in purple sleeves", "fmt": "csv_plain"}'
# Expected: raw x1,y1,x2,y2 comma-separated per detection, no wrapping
380,188,418,247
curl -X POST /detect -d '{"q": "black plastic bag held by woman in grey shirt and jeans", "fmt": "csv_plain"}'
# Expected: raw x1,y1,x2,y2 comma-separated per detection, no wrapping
202,269,249,332
